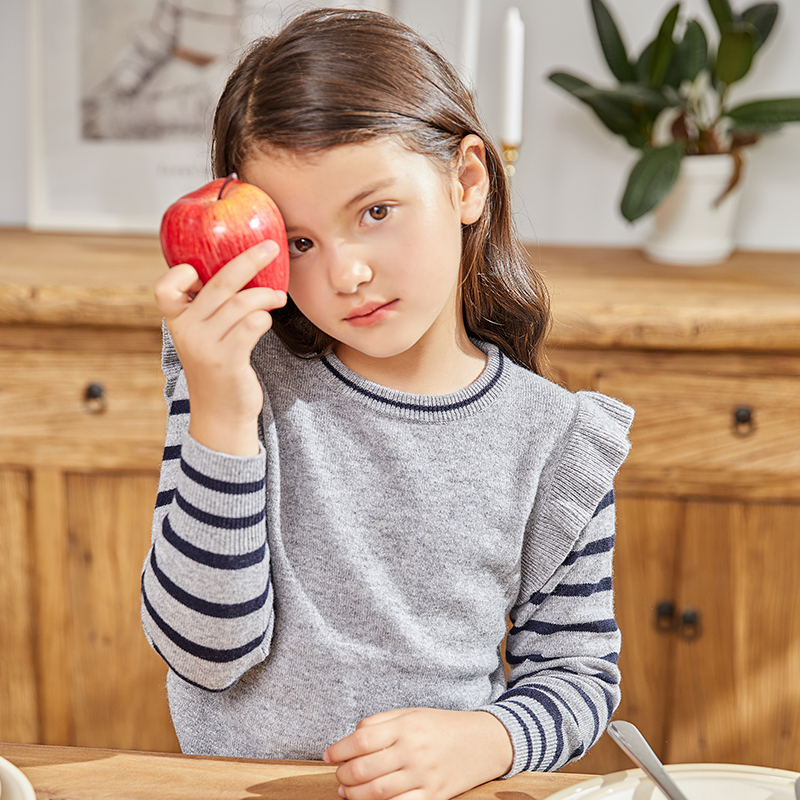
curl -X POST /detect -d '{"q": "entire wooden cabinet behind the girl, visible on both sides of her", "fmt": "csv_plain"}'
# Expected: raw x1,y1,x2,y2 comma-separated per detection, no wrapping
0,231,800,772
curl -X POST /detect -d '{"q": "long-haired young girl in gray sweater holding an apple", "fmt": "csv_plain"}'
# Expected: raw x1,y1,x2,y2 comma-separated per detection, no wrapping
142,9,631,800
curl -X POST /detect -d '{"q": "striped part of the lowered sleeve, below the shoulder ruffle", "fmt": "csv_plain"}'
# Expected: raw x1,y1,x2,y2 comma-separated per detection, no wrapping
484,492,620,775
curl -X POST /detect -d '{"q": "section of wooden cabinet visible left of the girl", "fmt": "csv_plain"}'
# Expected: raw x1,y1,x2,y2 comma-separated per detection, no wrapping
0,232,179,751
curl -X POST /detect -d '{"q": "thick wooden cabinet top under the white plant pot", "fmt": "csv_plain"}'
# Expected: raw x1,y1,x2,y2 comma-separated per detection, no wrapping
528,246,800,352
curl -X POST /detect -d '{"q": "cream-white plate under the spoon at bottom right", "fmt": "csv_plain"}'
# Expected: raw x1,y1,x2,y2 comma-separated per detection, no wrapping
548,764,798,800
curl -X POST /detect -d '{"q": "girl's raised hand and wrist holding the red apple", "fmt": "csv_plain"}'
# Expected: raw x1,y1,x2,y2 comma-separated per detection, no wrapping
153,241,286,456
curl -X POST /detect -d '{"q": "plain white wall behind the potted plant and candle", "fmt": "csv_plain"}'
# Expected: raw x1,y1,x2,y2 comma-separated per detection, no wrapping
0,0,800,250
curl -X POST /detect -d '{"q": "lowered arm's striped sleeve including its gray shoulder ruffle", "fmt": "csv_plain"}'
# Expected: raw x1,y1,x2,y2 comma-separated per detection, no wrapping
485,392,633,775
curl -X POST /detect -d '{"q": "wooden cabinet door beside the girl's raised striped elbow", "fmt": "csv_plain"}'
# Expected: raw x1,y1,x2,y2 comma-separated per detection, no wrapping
36,471,179,751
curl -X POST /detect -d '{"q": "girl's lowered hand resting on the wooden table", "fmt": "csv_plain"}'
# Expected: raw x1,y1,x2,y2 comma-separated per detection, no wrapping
324,708,514,800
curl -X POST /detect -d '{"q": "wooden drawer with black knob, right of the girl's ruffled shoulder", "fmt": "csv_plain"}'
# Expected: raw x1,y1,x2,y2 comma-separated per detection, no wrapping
597,371,800,498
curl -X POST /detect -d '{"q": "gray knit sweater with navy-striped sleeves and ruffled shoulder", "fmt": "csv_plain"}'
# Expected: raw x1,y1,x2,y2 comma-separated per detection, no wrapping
142,332,632,775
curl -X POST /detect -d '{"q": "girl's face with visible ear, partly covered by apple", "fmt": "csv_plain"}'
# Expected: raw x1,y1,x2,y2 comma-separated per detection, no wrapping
242,135,488,380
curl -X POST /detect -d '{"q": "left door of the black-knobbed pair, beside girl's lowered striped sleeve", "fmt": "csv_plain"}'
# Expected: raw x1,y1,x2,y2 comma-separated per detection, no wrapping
566,495,683,774
